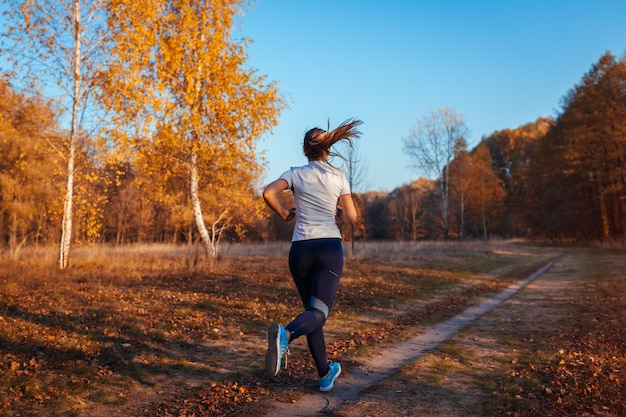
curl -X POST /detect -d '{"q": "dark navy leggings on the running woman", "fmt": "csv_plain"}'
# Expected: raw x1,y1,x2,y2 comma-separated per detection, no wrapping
286,239,343,377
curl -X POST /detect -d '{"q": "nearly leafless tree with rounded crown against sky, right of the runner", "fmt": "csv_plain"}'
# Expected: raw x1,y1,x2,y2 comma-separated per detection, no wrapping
403,107,468,240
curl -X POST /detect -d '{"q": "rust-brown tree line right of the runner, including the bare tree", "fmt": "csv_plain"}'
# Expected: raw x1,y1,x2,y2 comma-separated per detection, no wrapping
360,52,626,242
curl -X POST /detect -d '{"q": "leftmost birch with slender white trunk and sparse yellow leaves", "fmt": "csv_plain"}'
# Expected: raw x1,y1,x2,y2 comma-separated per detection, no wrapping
2,0,112,269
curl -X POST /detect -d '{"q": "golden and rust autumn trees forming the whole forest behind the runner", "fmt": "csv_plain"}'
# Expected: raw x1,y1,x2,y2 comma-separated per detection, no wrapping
0,0,626,268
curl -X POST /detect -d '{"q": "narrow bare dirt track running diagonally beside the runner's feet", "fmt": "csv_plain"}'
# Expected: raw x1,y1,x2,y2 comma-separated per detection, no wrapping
267,255,559,417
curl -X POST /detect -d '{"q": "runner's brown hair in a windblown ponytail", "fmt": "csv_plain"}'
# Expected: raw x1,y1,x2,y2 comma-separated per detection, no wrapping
303,119,363,160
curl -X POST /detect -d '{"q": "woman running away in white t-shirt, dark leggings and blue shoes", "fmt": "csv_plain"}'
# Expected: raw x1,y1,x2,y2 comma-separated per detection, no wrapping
263,120,362,391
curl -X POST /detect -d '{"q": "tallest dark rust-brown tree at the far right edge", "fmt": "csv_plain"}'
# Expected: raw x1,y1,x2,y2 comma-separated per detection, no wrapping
555,53,626,239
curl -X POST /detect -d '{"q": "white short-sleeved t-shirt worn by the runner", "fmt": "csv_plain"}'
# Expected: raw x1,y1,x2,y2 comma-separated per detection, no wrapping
280,161,350,242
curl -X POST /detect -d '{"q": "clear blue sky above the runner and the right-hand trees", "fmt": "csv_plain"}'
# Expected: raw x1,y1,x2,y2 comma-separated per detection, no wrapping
239,0,626,191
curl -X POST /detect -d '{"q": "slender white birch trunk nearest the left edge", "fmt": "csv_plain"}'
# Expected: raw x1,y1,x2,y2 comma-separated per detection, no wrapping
59,0,81,269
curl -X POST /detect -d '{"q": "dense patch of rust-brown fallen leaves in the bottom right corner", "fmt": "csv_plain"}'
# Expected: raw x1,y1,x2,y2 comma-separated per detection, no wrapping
492,268,626,417
